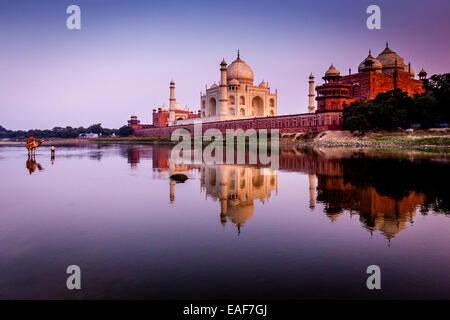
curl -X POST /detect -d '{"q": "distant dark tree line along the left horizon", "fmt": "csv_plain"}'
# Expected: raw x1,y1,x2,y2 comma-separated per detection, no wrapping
0,123,133,140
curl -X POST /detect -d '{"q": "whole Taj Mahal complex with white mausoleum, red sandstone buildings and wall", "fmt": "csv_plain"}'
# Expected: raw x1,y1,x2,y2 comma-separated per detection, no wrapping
128,42,427,136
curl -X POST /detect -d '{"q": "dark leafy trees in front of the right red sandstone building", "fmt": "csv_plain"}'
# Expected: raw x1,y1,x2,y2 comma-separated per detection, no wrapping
343,73,450,133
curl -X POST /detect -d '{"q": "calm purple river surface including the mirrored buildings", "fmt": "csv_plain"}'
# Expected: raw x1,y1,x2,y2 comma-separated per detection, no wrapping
0,145,450,299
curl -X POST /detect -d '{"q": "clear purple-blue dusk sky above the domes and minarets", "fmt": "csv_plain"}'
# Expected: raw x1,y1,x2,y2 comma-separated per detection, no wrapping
0,0,450,130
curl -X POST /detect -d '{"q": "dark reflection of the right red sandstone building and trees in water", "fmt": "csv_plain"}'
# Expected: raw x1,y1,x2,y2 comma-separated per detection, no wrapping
280,148,449,240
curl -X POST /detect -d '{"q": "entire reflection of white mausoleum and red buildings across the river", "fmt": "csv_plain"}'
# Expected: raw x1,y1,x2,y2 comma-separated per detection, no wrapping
128,146,448,240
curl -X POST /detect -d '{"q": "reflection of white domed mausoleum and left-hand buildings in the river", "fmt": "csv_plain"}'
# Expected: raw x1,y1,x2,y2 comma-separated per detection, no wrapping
127,146,278,234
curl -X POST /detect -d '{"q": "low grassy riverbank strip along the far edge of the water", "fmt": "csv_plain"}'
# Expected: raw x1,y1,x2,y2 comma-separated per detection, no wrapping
0,129,450,150
